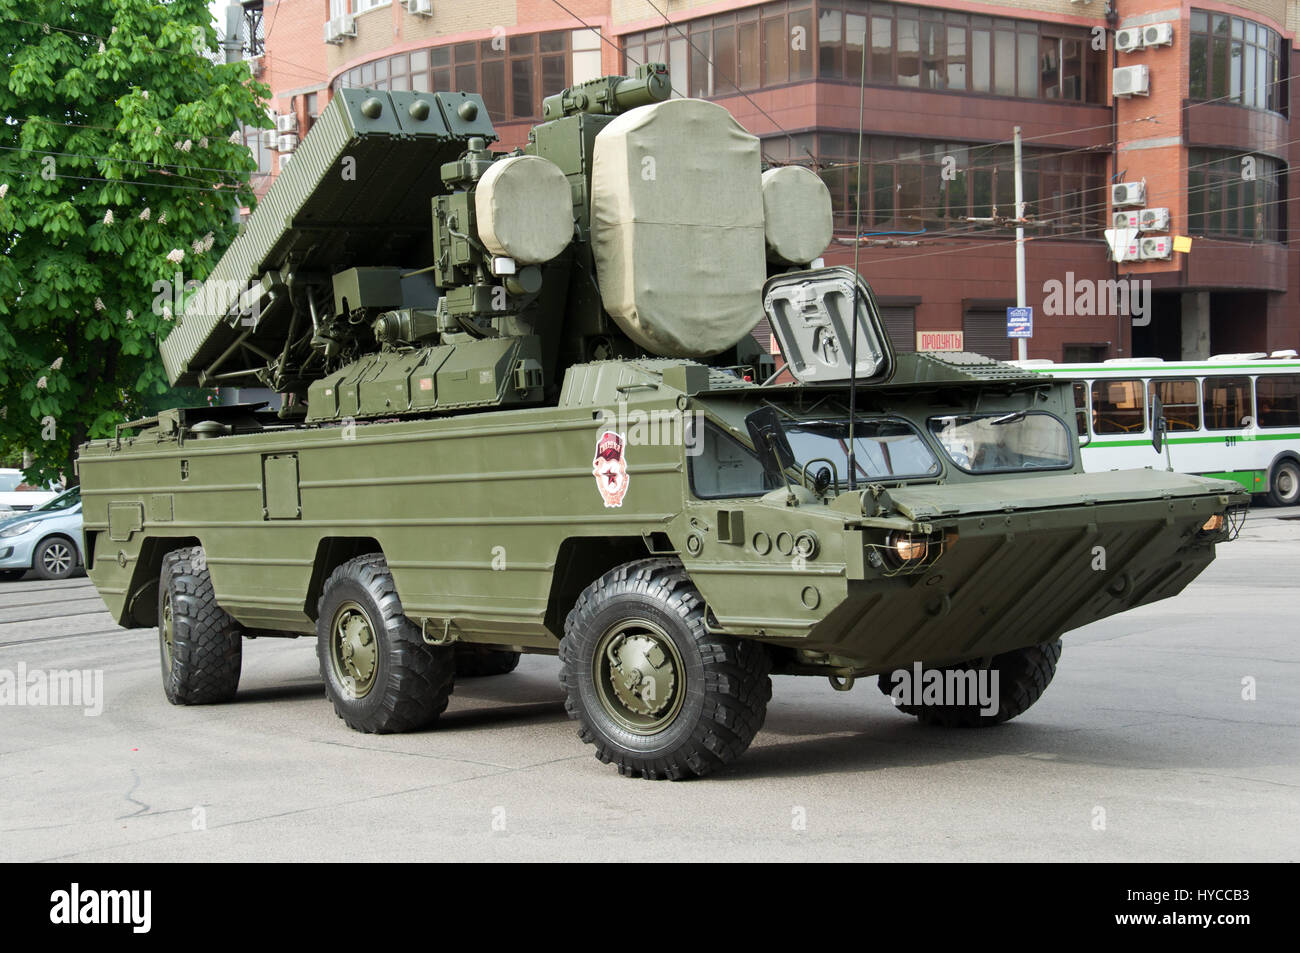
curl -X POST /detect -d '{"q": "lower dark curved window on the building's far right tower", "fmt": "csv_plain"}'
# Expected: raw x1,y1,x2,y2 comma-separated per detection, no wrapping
1187,150,1283,242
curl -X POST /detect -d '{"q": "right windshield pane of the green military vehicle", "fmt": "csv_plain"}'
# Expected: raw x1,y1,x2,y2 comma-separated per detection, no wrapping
930,411,1074,473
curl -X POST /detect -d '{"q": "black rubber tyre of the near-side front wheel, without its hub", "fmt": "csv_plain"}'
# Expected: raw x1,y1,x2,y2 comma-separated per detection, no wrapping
560,559,772,780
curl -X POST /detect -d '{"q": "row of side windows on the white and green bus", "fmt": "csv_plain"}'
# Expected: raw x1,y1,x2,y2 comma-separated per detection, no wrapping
1074,374,1300,436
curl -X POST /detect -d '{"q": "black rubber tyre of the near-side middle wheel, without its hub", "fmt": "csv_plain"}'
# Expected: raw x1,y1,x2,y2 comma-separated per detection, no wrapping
316,553,456,735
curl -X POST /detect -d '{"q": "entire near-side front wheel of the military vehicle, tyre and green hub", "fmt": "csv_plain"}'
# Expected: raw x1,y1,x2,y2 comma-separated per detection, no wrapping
560,559,772,780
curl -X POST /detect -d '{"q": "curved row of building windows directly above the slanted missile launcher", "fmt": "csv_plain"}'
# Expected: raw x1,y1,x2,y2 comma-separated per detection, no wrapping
334,30,569,122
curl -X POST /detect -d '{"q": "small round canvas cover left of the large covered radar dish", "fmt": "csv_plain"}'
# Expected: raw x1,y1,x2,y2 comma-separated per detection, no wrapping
475,156,573,265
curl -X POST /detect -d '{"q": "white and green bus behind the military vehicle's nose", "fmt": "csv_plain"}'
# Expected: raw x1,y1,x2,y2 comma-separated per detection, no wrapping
1017,351,1300,506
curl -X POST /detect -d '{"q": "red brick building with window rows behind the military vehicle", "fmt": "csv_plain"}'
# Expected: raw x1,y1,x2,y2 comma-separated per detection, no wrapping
233,0,1300,360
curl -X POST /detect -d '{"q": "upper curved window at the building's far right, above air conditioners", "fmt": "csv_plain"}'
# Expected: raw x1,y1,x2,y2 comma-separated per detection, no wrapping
1188,10,1286,113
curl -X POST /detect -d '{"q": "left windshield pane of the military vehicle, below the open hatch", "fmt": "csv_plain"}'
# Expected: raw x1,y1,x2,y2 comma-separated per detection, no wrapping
785,419,940,484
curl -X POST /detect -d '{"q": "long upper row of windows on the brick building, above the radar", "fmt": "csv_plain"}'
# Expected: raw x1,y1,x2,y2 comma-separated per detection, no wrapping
625,0,1106,103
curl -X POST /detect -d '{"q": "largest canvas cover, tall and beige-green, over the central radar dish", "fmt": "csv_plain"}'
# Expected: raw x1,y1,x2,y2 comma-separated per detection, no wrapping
592,99,767,358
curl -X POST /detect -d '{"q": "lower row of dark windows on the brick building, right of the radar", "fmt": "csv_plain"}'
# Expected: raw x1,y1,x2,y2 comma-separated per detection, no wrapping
763,133,1106,237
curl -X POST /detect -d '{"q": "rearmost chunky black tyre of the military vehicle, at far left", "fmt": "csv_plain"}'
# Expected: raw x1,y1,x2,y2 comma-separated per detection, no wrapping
159,546,243,705
